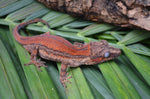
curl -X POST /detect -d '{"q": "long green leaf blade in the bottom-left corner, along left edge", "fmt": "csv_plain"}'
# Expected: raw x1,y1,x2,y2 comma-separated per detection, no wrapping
0,40,27,99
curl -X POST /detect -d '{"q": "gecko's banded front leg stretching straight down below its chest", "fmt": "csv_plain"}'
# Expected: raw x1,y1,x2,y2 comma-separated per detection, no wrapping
60,63,71,87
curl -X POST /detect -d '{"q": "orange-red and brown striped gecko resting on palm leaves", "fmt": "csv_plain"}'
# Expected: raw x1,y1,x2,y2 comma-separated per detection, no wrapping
13,19,121,87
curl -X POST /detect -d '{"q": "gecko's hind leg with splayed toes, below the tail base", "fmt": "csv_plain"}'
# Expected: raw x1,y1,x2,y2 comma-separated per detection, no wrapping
24,45,47,71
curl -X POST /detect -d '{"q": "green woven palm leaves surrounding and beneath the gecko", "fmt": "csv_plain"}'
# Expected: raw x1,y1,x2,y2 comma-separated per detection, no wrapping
0,0,150,99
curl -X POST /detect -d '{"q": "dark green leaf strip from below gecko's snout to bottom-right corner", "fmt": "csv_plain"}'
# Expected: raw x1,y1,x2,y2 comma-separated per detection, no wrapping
118,57,150,99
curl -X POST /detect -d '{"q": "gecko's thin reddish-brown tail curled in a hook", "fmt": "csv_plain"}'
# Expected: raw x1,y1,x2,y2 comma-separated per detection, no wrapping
13,19,50,43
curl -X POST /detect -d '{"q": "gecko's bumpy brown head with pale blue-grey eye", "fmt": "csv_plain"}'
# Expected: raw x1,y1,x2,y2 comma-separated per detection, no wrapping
90,40,121,64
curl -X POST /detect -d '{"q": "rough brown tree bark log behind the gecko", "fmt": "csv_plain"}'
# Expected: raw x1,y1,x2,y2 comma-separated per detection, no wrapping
38,0,150,31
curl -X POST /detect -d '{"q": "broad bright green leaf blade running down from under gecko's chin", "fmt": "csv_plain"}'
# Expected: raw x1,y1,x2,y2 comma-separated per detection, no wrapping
99,61,140,99
